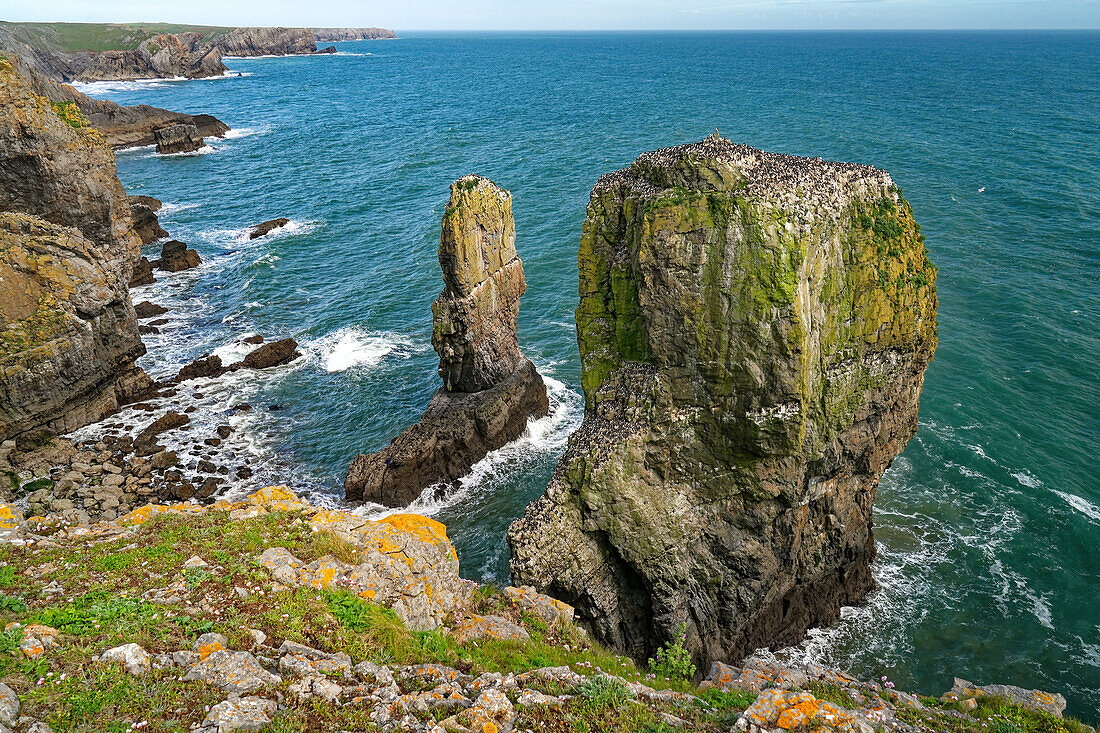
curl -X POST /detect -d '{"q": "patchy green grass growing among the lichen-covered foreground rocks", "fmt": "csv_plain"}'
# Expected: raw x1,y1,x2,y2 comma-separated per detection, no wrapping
0,501,1089,733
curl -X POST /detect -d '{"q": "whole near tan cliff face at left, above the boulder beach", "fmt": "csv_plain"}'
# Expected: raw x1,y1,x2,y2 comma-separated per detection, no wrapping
0,61,147,438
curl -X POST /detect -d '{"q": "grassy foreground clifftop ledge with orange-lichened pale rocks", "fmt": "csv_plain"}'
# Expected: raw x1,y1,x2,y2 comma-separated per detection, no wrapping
0,486,1091,733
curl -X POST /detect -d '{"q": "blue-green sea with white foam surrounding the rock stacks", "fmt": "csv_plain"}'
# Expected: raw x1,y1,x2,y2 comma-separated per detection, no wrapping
86,33,1100,723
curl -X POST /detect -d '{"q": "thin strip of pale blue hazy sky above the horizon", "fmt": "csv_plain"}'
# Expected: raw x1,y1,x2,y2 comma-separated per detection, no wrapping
0,0,1100,31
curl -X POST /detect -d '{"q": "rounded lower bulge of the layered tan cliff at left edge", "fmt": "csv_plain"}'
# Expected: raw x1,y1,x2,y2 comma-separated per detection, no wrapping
0,214,145,438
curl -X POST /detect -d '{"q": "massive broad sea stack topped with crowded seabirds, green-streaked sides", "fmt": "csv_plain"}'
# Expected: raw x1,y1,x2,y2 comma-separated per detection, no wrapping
508,134,936,669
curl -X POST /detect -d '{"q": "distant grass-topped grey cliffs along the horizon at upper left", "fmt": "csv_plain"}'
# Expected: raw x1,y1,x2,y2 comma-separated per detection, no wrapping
0,23,394,83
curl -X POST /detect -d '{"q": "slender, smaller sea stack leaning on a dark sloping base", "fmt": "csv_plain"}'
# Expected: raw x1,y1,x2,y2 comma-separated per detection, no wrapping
344,176,549,506
